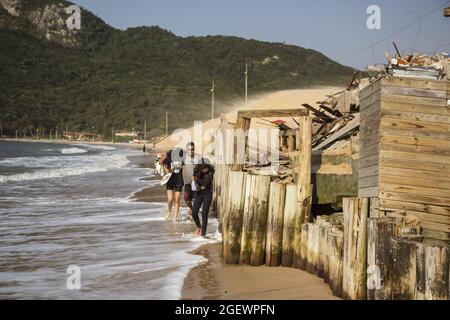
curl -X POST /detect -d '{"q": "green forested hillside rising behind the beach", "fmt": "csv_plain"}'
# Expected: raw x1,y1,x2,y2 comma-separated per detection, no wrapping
0,0,353,136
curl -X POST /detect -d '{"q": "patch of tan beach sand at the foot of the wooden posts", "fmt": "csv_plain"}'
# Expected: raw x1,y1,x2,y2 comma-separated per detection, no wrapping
182,243,340,300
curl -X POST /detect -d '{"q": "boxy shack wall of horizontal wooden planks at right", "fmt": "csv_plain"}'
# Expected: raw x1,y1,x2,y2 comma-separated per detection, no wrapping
358,77,450,241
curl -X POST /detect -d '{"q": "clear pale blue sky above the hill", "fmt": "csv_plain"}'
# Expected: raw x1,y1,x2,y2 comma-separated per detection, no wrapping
73,0,450,68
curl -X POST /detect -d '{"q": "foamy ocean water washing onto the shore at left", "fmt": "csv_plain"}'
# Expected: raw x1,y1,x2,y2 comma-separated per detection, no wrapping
0,141,218,299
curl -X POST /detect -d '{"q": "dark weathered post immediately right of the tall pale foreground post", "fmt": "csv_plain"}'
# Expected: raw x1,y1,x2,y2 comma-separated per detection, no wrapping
367,218,394,300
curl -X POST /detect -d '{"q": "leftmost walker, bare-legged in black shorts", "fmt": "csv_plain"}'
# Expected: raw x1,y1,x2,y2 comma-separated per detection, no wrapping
162,148,184,222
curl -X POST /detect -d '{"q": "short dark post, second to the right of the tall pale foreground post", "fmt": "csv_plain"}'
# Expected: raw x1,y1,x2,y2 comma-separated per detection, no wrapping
390,238,418,300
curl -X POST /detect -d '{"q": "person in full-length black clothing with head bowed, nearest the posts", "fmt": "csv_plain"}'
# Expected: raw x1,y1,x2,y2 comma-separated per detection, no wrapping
192,161,214,237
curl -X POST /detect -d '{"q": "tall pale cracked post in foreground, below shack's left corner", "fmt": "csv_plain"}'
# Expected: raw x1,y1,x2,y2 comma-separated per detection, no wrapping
342,198,369,300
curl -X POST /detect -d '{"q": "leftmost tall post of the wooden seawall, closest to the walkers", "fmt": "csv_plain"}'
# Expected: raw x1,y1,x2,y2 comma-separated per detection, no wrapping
223,172,246,264
